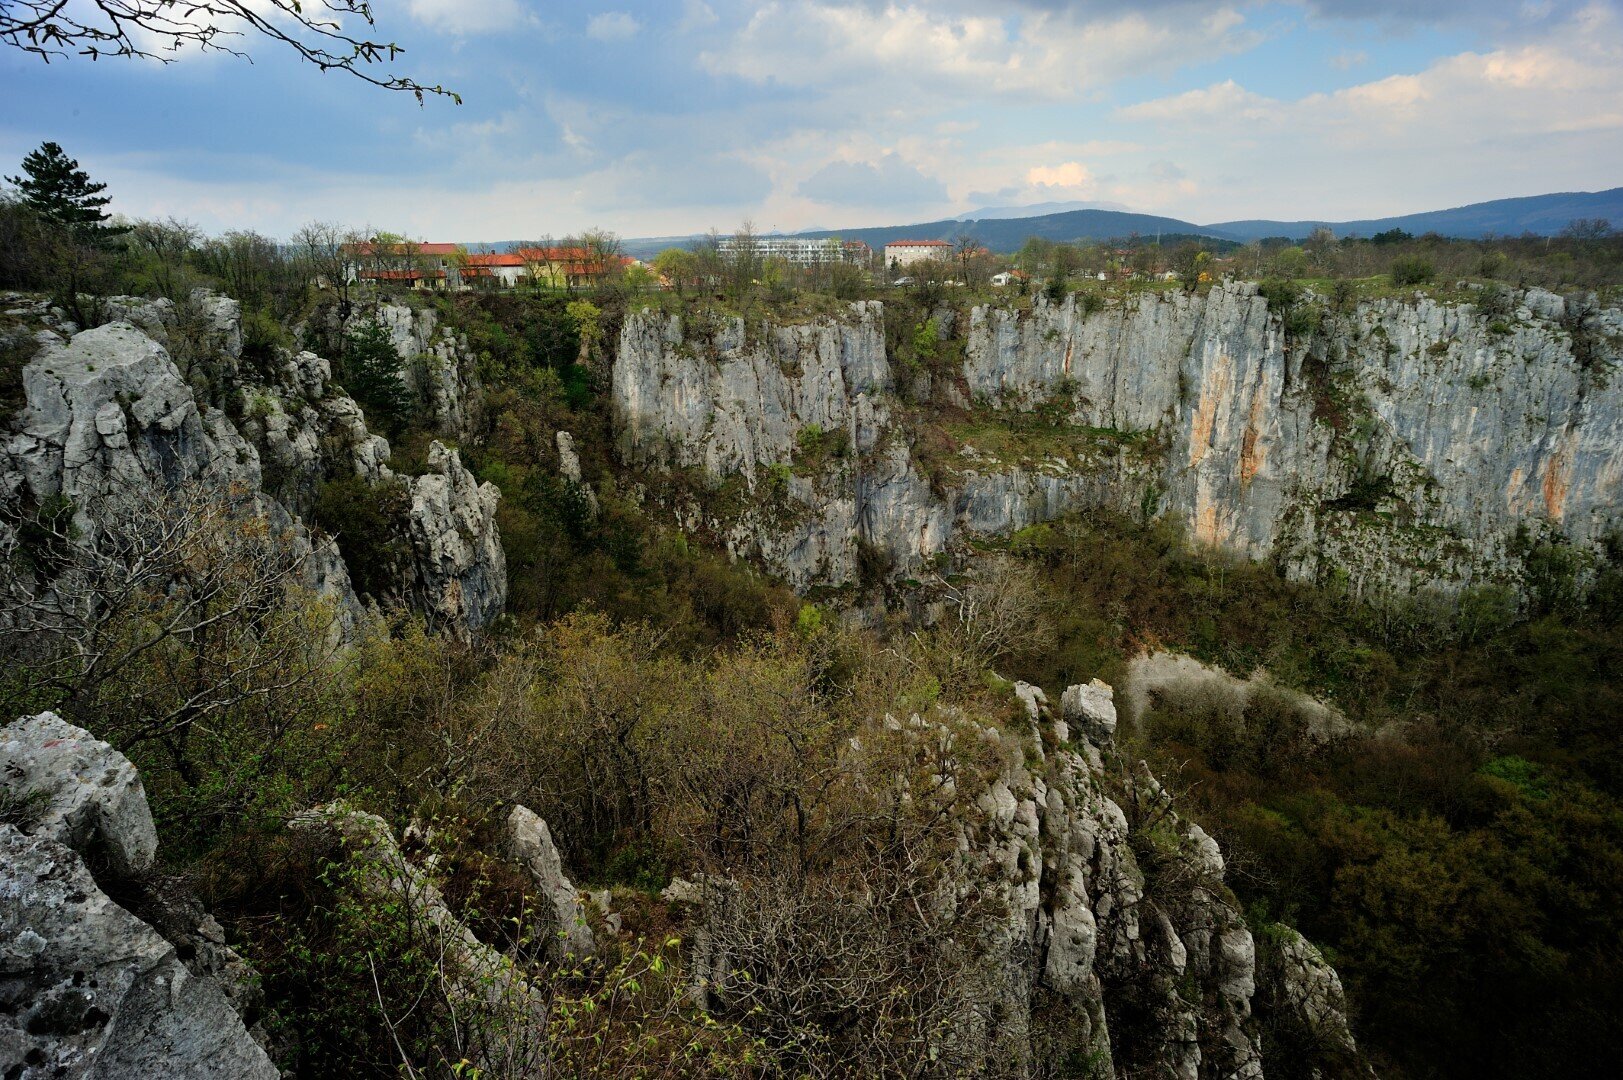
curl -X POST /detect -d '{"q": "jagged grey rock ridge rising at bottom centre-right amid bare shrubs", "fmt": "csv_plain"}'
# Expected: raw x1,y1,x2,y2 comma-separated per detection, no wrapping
664,680,1357,1080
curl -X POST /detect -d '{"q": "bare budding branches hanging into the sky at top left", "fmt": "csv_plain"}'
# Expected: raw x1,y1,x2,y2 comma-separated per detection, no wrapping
0,0,463,104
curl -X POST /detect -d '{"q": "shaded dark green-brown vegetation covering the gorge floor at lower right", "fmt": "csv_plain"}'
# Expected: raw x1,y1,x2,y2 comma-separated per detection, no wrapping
1006,515,1623,1077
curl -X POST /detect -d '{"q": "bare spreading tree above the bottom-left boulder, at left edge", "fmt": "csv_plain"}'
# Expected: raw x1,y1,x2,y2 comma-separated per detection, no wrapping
0,481,339,786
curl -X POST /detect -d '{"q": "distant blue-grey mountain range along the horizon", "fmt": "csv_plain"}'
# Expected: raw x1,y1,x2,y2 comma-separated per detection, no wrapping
610,187,1623,258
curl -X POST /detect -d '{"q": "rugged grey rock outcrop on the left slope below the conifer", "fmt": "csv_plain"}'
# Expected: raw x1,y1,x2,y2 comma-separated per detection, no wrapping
0,294,506,635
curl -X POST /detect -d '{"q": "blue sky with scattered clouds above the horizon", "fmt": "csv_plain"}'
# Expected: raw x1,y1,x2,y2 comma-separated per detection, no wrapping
0,0,1623,240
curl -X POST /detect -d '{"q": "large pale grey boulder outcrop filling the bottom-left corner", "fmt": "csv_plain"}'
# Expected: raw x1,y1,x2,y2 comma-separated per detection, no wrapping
0,713,279,1080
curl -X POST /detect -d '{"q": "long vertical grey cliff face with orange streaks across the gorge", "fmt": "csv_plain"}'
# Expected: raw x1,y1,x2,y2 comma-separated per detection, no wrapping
613,283,1623,590
